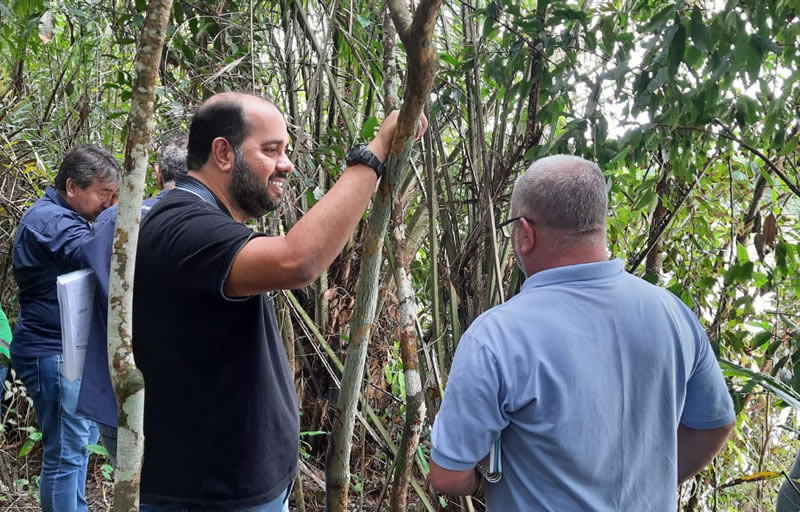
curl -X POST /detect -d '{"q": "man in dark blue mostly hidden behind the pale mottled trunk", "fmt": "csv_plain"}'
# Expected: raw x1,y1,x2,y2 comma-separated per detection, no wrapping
76,134,189,465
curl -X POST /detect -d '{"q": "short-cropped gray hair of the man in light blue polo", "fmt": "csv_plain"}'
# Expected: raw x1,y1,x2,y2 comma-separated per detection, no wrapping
511,155,608,234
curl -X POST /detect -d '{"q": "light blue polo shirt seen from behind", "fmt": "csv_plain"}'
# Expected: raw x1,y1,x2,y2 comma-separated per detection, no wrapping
432,260,734,512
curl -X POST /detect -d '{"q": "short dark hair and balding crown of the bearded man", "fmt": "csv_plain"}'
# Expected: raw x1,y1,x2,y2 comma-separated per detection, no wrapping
186,92,277,171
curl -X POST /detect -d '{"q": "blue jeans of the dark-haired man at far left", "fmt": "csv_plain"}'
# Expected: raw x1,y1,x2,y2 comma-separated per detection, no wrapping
11,354,99,512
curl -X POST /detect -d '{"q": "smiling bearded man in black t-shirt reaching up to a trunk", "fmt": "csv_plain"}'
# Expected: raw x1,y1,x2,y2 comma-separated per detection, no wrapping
133,93,427,512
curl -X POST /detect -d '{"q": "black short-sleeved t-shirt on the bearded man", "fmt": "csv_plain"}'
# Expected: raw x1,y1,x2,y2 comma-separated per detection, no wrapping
133,178,299,509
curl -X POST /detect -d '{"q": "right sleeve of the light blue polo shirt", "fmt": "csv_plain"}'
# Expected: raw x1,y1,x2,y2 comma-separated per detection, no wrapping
681,324,735,430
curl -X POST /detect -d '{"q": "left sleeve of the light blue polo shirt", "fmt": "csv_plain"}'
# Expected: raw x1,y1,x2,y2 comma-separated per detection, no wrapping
431,334,509,471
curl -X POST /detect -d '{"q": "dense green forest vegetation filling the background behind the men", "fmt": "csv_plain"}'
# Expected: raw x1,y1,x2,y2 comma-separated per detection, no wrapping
0,0,800,510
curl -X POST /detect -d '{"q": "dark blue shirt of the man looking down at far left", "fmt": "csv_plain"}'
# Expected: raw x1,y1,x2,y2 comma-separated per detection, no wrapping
11,187,91,357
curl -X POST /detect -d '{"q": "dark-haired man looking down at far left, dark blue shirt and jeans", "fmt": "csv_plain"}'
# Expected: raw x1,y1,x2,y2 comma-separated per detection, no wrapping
11,145,120,512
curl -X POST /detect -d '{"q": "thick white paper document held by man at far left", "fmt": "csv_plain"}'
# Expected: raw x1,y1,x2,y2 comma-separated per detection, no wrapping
56,269,97,380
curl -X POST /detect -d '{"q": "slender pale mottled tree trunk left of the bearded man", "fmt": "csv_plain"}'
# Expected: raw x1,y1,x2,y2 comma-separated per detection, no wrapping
108,0,172,512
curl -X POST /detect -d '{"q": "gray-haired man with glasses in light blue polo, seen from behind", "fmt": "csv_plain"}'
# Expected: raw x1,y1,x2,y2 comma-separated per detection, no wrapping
430,155,734,511
